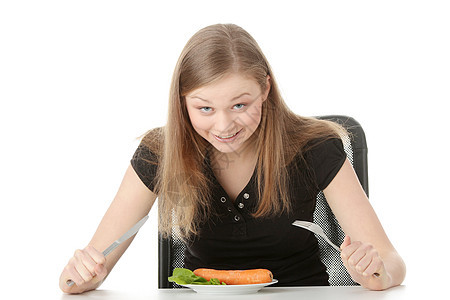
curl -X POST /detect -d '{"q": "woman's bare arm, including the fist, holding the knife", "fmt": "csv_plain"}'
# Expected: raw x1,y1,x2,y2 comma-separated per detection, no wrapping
59,165,156,294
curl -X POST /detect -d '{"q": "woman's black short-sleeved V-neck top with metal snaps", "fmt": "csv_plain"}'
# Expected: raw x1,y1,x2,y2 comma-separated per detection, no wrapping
131,139,346,286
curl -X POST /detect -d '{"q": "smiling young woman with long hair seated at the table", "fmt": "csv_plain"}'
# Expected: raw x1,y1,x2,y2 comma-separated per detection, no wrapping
60,24,405,293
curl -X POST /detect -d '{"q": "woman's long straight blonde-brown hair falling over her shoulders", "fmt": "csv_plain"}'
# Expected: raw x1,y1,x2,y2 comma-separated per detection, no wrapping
143,24,341,238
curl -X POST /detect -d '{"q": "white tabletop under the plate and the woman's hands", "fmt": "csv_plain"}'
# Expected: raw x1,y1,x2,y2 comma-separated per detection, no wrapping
60,286,432,300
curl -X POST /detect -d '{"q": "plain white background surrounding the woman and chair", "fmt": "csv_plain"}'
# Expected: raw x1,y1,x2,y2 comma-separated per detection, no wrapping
0,0,450,299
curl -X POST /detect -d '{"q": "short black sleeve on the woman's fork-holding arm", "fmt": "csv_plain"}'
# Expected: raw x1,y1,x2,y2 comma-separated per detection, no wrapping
308,138,347,190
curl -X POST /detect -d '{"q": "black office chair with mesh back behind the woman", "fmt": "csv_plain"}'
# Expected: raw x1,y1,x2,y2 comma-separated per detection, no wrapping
158,115,369,288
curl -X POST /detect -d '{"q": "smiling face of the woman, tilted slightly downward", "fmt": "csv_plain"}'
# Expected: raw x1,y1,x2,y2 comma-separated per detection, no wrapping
186,73,270,153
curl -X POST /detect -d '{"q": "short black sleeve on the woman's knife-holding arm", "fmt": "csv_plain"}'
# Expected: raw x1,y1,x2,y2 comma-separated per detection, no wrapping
131,142,158,192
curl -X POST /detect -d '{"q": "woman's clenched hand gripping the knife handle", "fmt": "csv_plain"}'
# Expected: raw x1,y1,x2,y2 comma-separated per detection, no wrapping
59,246,108,294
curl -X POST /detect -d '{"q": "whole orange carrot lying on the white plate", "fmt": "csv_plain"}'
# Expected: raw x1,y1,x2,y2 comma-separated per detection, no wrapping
194,268,273,284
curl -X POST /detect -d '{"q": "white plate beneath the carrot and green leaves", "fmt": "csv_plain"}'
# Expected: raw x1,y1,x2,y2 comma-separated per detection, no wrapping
182,279,278,295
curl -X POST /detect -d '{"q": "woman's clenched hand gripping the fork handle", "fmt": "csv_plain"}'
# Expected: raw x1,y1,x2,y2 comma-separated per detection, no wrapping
341,236,390,290
